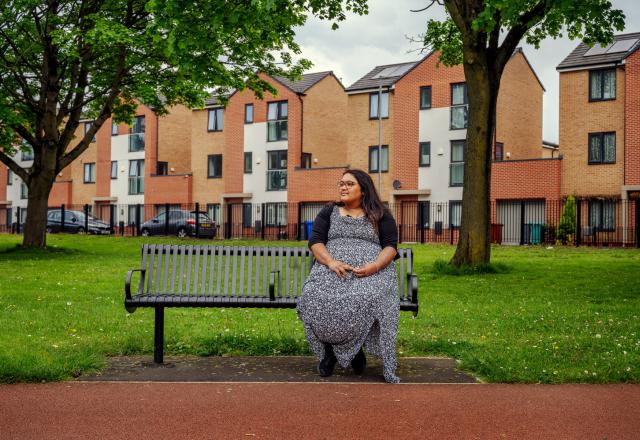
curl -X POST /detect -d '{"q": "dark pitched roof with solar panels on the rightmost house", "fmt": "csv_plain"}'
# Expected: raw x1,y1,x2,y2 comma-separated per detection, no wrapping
556,32,640,70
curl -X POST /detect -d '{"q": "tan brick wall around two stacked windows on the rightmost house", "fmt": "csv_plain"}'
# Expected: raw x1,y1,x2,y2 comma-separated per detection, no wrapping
560,68,625,196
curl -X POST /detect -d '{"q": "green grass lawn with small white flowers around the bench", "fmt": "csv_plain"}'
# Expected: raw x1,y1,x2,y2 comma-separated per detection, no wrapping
0,234,640,383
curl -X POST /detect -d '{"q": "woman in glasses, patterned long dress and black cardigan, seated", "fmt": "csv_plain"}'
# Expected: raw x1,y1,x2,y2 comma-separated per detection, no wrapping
298,169,400,383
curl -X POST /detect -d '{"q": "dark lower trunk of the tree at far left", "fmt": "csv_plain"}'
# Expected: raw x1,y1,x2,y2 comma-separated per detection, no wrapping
22,173,55,248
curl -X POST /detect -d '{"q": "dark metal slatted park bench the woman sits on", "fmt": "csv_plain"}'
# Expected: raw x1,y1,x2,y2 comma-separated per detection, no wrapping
124,244,418,364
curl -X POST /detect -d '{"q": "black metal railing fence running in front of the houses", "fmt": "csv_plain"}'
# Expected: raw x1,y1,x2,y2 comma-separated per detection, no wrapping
0,197,640,247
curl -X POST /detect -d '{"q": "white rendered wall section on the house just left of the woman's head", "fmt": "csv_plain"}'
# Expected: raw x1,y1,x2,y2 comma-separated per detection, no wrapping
239,122,289,203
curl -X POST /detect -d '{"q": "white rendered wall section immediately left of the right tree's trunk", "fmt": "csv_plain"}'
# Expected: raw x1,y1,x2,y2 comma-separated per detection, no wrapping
416,107,467,203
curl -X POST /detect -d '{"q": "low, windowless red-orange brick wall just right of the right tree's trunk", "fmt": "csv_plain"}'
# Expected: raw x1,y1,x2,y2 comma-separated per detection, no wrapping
491,158,562,201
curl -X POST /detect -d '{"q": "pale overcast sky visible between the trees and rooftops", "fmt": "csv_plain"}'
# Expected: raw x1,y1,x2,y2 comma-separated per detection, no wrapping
297,0,640,142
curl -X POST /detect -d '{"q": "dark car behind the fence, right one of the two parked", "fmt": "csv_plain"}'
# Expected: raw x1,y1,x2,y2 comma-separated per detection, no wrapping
140,210,216,238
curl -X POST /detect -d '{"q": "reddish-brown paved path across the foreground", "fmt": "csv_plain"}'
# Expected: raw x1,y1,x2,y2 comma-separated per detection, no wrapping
0,382,640,440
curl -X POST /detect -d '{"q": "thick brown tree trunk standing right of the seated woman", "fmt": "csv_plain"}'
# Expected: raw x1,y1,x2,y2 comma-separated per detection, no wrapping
451,58,500,267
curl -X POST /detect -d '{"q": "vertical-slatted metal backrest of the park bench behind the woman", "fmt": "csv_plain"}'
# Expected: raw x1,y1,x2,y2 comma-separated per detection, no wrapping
138,244,413,301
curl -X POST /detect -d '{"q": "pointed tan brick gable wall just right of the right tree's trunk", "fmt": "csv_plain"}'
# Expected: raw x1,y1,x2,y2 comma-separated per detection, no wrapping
496,51,544,160
